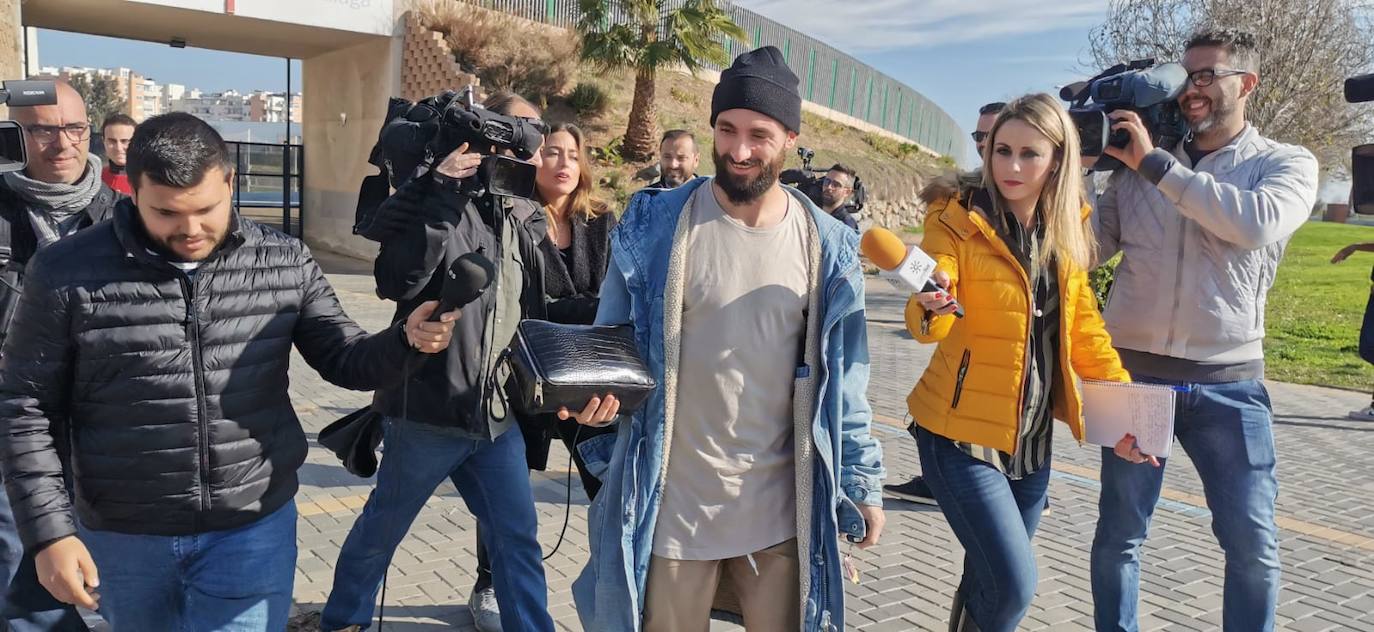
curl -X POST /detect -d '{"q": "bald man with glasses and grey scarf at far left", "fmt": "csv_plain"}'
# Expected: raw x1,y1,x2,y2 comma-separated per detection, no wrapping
0,81,121,632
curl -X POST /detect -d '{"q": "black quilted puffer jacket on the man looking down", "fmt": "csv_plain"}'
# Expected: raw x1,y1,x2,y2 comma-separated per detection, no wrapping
0,202,412,548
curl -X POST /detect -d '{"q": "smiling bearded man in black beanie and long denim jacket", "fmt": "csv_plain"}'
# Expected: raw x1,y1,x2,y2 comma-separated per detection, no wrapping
562,47,883,632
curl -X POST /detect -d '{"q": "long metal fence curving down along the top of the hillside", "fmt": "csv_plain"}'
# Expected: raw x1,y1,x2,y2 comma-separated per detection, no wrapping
466,0,967,161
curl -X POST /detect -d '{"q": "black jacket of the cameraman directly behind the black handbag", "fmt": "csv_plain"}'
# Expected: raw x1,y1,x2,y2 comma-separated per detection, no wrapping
372,177,547,437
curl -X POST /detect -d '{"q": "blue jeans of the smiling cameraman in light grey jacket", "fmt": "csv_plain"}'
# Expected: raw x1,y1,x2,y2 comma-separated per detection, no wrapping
1091,375,1279,632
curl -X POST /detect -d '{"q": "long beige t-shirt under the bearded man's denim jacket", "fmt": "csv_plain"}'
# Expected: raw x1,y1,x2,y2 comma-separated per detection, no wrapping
654,184,811,559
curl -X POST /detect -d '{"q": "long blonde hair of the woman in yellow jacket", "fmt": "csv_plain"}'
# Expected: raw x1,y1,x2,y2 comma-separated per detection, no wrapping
981,92,1098,269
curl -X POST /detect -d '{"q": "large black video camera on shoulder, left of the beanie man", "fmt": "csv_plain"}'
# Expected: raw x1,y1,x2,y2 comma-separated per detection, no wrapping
353,85,548,240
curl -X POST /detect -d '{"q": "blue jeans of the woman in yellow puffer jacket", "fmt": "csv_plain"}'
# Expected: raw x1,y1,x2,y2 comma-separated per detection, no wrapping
916,429,1050,632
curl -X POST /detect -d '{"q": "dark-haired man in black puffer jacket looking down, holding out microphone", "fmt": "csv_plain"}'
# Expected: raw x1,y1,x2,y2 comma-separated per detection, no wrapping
0,114,458,632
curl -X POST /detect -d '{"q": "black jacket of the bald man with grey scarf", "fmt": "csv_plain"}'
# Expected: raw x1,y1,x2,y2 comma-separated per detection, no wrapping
0,180,124,343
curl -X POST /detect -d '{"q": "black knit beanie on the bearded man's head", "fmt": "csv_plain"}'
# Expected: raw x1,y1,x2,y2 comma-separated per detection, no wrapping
710,47,801,132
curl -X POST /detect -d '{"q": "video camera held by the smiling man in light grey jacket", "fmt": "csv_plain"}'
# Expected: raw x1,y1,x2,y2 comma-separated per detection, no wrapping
1059,59,1189,172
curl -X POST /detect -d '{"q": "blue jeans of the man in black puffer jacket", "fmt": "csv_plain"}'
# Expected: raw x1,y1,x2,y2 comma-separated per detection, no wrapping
80,501,295,632
